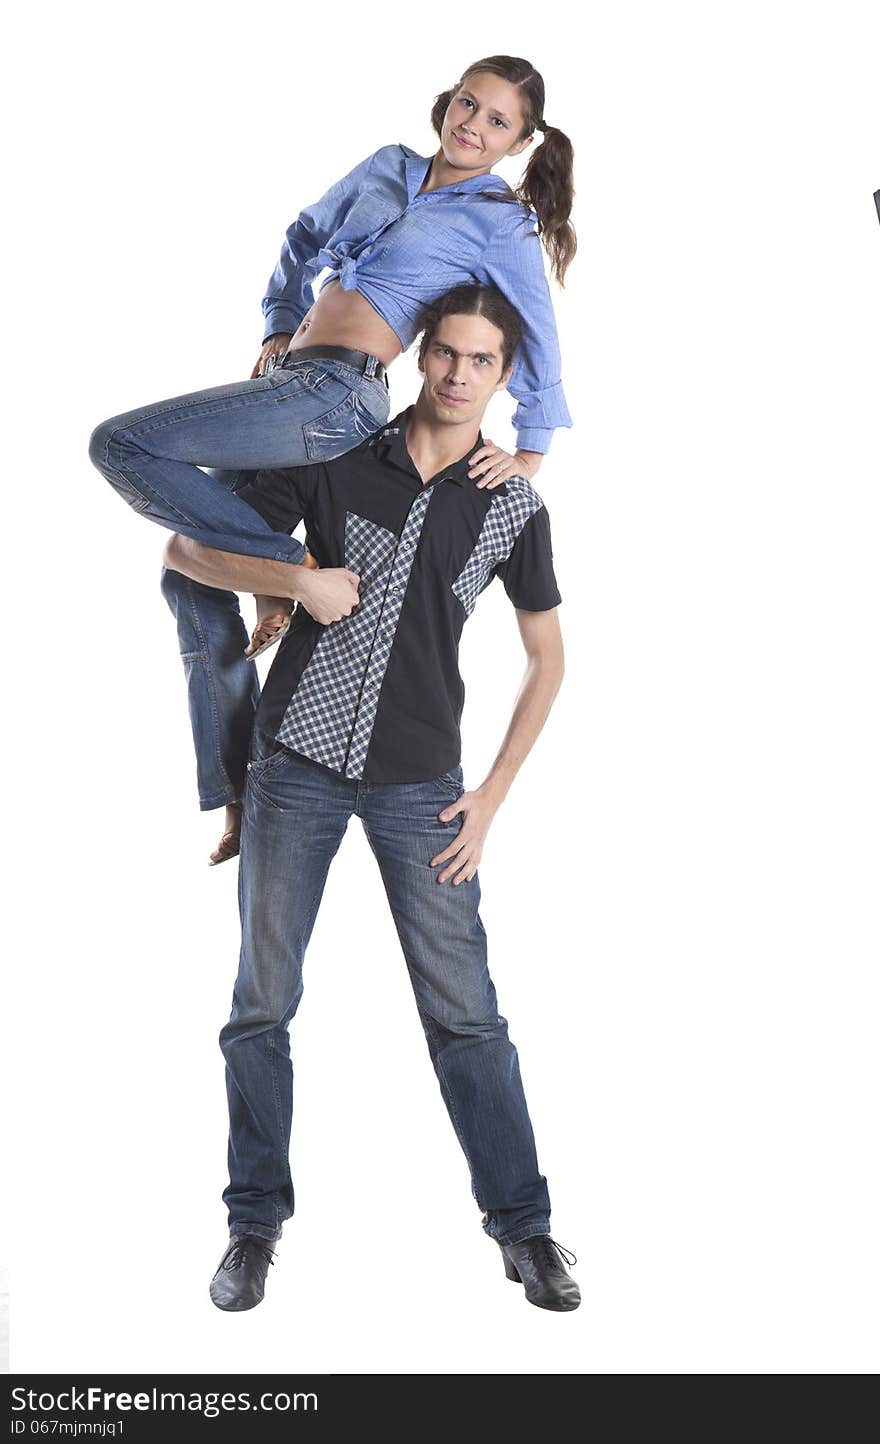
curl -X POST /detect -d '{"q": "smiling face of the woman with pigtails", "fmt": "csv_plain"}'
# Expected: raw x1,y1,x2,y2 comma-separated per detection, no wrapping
441,71,532,175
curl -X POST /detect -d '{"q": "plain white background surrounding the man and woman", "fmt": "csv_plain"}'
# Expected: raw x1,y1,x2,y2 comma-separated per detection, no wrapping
1,0,880,1375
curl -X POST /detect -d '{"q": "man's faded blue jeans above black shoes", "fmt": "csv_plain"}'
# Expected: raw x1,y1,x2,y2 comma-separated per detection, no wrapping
220,732,551,1243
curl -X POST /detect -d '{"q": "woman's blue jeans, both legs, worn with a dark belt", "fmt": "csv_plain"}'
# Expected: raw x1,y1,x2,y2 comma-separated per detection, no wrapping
90,351,389,809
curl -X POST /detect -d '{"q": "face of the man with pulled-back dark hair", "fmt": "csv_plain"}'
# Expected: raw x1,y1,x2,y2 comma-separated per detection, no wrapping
419,316,512,426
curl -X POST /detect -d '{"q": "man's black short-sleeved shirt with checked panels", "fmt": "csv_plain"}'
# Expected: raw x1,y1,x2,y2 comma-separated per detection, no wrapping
238,409,561,783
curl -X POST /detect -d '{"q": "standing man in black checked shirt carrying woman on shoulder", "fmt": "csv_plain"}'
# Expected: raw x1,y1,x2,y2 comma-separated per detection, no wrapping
166,286,579,1311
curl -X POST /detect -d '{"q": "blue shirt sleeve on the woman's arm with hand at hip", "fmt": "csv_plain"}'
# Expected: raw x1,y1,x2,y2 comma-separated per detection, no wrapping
257,152,376,341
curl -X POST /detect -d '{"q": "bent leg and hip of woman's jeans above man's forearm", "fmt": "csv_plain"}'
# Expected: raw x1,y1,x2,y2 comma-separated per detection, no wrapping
90,351,389,562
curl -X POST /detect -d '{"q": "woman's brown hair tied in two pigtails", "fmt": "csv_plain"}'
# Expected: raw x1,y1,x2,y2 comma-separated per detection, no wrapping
431,55,578,286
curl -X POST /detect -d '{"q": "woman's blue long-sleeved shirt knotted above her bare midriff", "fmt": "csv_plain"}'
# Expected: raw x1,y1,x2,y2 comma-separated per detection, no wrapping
263,146,572,452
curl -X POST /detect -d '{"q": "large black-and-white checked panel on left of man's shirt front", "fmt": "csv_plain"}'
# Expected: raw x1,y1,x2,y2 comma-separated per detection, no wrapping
277,508,432,777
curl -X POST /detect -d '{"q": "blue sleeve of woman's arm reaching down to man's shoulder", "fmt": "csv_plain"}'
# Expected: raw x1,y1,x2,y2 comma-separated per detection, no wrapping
483,206,572,452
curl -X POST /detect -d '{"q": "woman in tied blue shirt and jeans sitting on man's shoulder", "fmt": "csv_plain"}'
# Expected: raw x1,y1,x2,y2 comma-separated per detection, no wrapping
91,55,575,862
